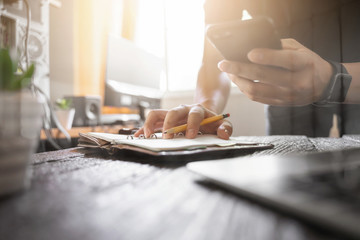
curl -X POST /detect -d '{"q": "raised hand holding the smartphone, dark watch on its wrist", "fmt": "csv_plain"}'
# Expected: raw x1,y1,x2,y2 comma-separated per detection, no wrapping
219,39,332,106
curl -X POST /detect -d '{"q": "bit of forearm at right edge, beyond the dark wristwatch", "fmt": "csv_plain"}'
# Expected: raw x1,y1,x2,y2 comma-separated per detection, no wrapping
344,62,360,103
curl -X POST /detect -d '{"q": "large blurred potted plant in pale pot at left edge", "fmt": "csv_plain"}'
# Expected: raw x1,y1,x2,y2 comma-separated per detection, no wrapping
0,49,42,195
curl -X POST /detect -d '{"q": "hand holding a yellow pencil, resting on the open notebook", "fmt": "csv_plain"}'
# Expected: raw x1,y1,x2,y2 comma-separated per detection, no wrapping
134,104,232,139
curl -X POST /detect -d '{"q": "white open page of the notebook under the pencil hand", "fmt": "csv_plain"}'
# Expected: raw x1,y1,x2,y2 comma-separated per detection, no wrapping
87,132,250,152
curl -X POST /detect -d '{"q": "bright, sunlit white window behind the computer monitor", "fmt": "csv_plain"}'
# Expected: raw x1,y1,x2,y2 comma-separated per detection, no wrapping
114,0,204,91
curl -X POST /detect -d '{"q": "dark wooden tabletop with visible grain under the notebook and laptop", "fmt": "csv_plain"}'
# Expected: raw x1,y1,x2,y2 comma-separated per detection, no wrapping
0,136,360,240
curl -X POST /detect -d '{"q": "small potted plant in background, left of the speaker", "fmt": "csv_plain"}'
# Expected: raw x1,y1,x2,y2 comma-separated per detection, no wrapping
55,98,75,129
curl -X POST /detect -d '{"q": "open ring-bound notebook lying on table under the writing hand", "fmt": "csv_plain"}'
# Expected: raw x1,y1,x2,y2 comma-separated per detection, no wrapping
78,132,273,160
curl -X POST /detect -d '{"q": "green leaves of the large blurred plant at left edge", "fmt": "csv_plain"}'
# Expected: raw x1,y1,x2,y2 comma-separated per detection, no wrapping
0,48,35,91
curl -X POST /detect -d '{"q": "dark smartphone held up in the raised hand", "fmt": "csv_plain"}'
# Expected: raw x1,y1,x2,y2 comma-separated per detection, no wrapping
206,17,282,62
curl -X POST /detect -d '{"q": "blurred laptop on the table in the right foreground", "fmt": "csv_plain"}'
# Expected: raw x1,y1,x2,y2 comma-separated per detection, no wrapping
187,148,360,239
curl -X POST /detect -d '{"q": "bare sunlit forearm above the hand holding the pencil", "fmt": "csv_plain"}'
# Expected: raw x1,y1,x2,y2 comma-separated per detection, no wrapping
195,62,231,113
